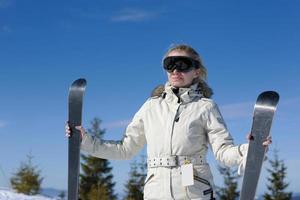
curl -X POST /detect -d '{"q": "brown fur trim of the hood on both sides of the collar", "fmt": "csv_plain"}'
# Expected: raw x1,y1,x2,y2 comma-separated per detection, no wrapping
151,81,213,98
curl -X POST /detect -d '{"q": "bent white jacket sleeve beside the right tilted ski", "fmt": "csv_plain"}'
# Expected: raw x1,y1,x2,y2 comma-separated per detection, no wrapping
202,102,248,173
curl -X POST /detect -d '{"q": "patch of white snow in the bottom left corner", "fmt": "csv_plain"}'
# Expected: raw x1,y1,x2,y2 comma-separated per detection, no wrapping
0,188,57,200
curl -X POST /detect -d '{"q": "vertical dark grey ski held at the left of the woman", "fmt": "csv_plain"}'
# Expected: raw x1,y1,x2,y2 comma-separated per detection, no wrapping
68,79,86,200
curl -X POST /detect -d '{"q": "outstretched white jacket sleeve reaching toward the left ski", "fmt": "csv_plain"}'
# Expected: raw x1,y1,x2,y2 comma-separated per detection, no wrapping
81,102,147,160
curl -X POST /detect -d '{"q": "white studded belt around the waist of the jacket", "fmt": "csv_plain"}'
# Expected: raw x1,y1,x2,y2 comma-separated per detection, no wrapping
147,155,206,168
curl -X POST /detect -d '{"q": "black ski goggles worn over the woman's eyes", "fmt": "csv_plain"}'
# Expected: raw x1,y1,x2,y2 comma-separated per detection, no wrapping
163,56,200,72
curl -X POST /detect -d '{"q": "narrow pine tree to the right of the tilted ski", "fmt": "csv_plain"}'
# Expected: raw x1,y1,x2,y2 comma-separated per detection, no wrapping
264,149,292,200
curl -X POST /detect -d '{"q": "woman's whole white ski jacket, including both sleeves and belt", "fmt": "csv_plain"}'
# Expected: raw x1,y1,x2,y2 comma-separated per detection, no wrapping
81,83,247,200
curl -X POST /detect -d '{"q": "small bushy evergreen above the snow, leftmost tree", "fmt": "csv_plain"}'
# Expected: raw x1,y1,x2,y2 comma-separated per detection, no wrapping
10,154,43,195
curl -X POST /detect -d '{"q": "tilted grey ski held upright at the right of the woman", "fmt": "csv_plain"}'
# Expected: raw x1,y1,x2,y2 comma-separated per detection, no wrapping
240,91,279,200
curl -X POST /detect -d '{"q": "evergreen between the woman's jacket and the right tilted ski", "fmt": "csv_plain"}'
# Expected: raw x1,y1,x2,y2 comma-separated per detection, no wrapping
217,166,239,200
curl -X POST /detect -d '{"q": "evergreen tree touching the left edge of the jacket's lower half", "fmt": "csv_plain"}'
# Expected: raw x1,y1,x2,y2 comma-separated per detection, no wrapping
124,156,147,200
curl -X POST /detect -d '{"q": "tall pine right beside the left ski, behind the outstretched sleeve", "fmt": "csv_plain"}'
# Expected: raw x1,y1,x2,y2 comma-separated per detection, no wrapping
80,118,117,200
